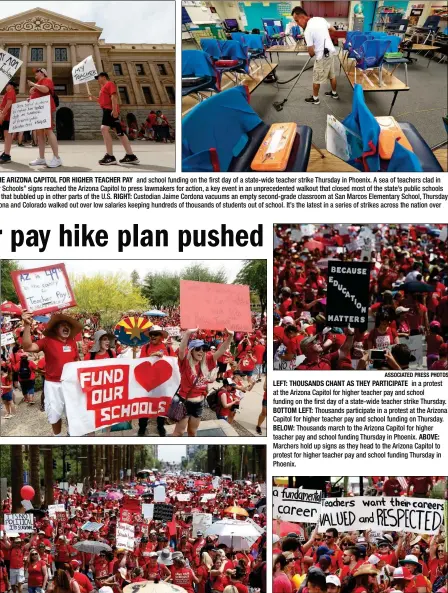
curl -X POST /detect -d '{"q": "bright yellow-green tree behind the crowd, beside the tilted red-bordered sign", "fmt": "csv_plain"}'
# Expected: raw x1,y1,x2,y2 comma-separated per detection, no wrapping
71,273,147,329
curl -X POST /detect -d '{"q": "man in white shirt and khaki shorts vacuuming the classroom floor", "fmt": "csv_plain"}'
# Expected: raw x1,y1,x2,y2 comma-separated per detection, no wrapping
291,6,339,105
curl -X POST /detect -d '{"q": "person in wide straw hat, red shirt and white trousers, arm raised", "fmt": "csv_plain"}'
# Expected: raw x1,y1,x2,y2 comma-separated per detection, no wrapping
22,311,82,436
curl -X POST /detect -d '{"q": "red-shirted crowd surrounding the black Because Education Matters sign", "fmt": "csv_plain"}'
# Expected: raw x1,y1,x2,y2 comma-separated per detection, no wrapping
273,224,448,370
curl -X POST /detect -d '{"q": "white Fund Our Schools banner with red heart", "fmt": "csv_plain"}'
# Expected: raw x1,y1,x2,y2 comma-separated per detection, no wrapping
62,356,180,436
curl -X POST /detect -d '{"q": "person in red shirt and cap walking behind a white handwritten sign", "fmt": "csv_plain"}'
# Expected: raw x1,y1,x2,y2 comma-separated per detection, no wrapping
28,68,62,168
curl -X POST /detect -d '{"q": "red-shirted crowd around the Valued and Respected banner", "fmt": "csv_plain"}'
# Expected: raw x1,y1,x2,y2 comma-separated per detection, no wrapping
273,476,448,593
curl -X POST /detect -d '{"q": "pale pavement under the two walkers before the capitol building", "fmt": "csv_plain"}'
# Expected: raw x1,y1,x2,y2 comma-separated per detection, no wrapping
0,140,176,173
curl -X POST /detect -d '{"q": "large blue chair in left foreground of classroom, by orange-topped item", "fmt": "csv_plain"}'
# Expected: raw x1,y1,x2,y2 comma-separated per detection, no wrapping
182,86,312,172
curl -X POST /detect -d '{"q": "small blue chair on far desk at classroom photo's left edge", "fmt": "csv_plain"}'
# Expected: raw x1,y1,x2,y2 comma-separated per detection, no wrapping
182,49,220,101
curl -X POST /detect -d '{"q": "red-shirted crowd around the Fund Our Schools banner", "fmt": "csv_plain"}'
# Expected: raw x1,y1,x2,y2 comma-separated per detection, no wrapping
1,308,266,436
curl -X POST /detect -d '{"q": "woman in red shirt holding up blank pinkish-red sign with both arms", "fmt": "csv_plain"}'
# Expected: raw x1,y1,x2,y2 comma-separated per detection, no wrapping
173,328,233,437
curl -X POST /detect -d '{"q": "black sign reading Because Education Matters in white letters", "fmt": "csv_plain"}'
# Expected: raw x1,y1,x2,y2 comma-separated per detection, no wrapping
327,261,370,329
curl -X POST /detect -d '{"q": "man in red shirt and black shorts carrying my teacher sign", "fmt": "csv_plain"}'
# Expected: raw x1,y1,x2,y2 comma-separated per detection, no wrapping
89,72,140,165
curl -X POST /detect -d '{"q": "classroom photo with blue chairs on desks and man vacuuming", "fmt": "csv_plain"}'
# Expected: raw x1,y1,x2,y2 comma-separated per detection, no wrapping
182,0,448,173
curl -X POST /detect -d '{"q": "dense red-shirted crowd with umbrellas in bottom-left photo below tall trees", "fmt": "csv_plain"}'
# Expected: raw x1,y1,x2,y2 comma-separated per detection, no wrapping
0,472,266,593
